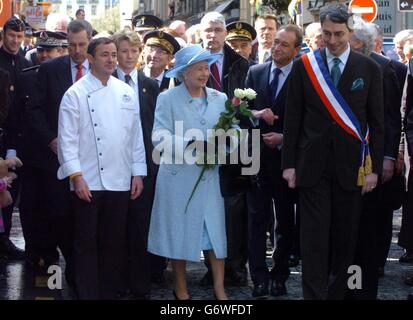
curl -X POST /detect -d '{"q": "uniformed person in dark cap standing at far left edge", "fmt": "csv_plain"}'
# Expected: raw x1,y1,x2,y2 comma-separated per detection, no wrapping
0,17,30,260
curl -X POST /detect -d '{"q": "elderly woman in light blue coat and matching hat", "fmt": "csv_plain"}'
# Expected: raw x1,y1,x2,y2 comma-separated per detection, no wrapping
148,45,227,299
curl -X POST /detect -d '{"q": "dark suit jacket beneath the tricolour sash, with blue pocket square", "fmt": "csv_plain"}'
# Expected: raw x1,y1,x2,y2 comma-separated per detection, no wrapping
282,50,384,190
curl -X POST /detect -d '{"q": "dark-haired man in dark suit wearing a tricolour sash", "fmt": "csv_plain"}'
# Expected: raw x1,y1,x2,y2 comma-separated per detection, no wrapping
282,4,384,299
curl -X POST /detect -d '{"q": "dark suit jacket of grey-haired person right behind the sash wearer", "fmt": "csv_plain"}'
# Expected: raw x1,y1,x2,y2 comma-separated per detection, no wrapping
370,52,402,159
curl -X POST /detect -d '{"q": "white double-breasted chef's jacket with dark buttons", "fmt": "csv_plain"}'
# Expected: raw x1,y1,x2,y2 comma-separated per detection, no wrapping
57,73,147,191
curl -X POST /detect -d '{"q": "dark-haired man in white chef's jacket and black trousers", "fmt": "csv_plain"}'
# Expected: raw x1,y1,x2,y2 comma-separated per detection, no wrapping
57,38,146,299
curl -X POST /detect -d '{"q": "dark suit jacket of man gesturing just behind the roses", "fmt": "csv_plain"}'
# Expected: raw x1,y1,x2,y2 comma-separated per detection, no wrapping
245,61,289,181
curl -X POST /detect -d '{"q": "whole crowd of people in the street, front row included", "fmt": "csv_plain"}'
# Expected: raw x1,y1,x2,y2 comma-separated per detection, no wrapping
0,4,413,300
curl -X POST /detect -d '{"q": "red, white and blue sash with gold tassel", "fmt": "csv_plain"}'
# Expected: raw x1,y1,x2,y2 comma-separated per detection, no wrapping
302,49,372,186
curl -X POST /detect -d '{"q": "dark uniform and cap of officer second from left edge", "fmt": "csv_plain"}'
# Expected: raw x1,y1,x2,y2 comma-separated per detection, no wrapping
15,31,65,265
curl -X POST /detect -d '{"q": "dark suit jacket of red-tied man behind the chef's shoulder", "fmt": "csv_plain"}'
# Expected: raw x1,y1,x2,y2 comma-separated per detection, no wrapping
27,56,73,174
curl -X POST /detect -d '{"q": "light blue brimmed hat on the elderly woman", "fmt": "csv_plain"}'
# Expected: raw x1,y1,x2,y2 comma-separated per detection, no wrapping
165,44,222,78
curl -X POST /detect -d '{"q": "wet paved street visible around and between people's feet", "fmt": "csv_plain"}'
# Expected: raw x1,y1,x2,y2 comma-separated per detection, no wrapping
0,211,413,300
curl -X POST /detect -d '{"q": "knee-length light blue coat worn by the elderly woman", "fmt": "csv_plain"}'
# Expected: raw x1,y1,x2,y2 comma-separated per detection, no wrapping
148,84,227,261
